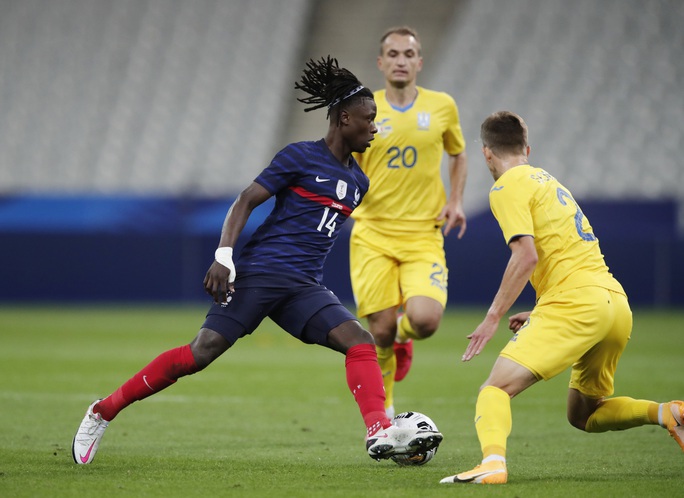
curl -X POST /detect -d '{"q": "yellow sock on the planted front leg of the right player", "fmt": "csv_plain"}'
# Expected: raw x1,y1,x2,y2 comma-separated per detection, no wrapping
475,386,513,459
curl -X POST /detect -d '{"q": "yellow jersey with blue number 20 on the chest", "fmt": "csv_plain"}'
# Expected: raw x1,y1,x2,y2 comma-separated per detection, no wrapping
352,87,465,232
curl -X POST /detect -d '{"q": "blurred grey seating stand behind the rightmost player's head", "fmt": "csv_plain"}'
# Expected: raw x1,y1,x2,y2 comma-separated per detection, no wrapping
433,0,684,215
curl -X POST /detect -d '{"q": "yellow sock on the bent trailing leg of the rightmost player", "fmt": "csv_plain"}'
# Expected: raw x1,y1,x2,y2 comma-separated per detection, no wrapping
584,396,659,432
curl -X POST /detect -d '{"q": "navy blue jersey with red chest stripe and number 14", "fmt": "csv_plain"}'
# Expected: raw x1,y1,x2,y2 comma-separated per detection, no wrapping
236,139,369,282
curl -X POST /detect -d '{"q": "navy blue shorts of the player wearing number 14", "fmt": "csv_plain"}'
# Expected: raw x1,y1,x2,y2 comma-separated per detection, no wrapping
202,273,356,346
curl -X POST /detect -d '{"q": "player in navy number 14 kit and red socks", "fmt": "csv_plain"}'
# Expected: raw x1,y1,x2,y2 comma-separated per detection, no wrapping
72,57,442,464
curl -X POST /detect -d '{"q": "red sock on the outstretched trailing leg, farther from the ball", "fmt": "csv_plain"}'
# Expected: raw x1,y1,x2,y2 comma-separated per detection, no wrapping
93,344,199,421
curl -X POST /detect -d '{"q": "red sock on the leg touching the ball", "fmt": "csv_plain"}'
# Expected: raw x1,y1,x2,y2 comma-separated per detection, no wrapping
345,344,392,436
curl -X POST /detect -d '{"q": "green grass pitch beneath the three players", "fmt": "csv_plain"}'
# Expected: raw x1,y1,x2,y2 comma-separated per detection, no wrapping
0,306,684,498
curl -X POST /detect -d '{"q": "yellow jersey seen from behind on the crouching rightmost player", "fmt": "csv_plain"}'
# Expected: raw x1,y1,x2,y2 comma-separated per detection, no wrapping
489,164,624,297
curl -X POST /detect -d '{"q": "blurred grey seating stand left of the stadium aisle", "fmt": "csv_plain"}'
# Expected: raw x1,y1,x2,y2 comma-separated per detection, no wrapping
0,0,311,195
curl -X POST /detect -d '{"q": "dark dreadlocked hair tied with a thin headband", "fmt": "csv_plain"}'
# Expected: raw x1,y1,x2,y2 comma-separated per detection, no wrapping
295,55,373,117
